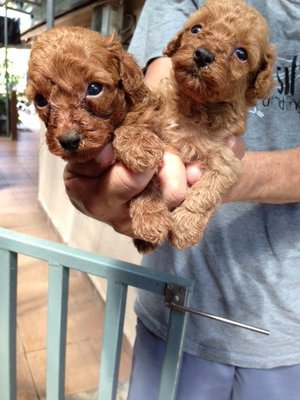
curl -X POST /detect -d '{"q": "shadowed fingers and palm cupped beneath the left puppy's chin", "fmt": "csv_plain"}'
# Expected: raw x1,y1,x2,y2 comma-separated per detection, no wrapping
64,151,155,236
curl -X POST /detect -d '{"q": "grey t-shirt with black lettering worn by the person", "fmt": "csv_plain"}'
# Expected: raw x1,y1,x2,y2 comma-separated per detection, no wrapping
129,0,300,368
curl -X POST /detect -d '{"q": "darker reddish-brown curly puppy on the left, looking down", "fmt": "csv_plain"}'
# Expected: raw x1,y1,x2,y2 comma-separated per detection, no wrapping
26,27,170,252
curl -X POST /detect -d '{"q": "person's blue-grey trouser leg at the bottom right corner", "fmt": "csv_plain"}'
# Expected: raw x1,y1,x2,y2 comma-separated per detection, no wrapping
232,364,300,400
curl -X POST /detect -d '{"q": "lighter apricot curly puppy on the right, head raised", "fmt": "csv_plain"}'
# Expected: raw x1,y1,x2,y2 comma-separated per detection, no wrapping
146,0,275,249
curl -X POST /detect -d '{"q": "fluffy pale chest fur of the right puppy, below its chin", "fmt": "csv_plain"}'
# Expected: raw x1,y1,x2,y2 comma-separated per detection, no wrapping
161,84,247,164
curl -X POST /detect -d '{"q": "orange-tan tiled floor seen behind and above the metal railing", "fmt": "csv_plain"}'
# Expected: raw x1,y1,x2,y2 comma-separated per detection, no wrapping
0,131,131,400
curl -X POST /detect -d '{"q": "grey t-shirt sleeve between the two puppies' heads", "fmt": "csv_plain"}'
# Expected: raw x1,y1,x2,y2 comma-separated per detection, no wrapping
128,0,197,68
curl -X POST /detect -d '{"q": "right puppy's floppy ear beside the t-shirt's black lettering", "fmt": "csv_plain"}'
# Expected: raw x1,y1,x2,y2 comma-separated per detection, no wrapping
246,45,276,105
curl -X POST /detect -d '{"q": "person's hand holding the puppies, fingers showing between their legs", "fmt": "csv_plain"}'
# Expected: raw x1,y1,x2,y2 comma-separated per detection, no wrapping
64,137,245,237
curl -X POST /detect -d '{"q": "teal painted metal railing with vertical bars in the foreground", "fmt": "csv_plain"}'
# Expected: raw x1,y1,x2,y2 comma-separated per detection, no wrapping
0,228,192,400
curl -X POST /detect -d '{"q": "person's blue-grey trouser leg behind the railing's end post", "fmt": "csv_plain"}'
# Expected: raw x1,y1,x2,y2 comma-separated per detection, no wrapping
128,322,236,400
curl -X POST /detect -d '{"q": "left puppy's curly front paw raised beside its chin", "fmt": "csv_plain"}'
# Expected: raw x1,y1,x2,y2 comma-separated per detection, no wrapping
113,126,163,172
